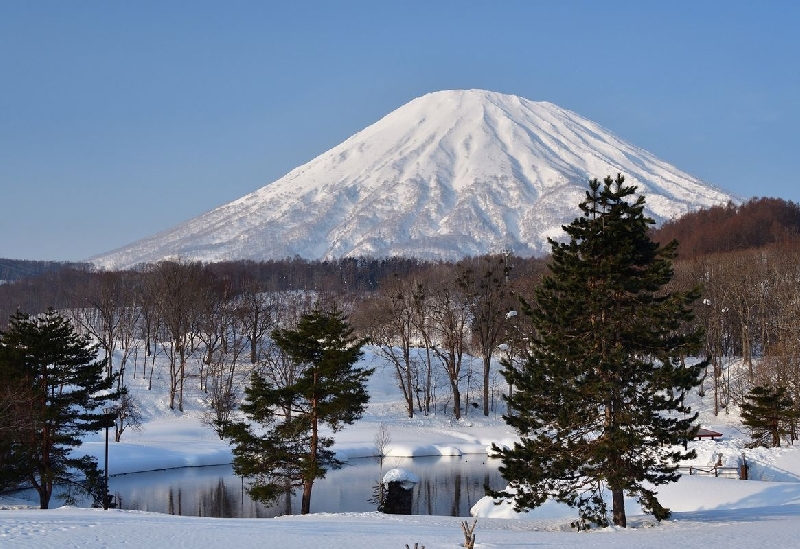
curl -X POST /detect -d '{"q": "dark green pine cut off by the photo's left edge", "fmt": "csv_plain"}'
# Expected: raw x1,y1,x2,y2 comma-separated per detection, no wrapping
0,309,118,509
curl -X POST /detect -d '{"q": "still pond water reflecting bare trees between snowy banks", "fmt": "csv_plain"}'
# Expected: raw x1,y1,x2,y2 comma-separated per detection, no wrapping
9,455,506,518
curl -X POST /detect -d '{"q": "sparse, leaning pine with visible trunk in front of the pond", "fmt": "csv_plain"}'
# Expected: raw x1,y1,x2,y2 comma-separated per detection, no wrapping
230,304,373,514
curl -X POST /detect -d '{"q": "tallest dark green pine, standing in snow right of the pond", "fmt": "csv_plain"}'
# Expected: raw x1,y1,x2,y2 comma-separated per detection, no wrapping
496,175,703,528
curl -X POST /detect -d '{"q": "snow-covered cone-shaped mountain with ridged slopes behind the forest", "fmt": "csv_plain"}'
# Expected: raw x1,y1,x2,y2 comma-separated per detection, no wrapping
90,90,735,269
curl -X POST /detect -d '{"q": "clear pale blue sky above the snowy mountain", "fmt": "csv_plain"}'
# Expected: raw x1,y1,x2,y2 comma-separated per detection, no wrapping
0,0,800,260
